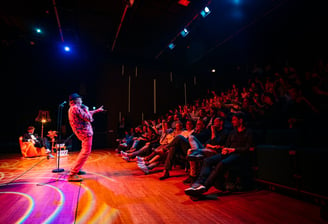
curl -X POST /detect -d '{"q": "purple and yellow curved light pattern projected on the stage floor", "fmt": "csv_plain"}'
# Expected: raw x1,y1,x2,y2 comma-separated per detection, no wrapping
0,152,119,223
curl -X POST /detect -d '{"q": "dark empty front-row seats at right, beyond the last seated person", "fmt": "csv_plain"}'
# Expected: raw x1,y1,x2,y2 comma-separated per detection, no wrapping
252,129,328,202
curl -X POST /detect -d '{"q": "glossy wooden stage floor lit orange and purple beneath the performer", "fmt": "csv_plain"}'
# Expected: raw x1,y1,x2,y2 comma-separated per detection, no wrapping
0,149,325,224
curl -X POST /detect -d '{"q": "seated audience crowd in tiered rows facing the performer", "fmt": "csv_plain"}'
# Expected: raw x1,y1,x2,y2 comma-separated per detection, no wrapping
116,60,328,196
